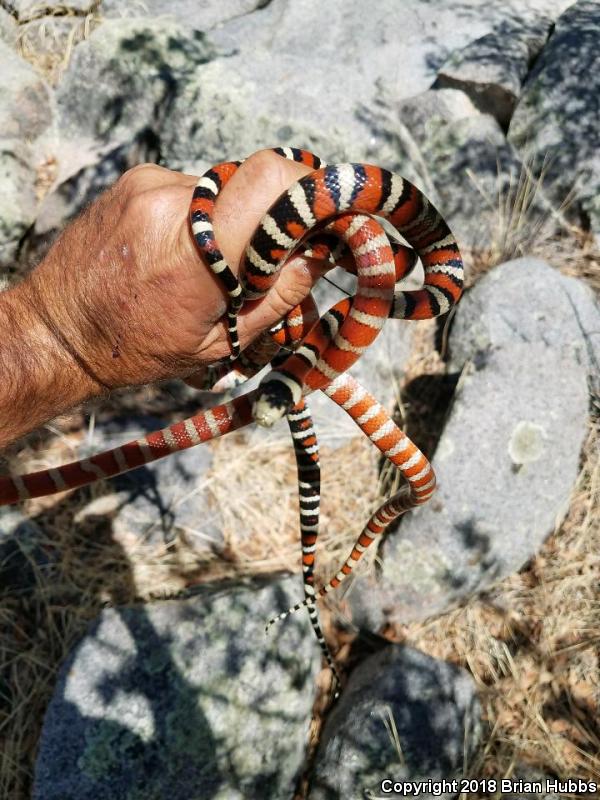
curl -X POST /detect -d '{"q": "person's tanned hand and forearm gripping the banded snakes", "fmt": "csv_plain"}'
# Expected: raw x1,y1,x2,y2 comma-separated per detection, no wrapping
0,151,326,448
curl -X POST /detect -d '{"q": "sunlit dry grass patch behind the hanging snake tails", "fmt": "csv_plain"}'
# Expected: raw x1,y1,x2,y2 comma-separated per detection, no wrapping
212,430,379,582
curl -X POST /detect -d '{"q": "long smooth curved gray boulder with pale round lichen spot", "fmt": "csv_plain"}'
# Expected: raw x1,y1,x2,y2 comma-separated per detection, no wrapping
349,259,600,630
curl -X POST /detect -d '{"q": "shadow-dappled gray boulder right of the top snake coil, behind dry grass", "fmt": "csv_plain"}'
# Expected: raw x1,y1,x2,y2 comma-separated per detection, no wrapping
361,88,562,252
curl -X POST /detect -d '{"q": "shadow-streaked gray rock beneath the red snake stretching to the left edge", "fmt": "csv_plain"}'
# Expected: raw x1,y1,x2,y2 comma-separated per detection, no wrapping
76,416,223,552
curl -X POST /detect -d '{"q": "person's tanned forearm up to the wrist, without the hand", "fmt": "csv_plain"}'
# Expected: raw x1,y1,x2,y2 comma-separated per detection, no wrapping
0,281,101,449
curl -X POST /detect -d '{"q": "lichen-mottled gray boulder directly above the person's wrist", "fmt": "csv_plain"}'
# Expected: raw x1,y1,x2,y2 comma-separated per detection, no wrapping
30,19,212,254
